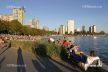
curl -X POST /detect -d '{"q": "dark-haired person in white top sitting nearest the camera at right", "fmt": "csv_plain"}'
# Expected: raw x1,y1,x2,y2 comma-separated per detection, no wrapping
79,50,100,71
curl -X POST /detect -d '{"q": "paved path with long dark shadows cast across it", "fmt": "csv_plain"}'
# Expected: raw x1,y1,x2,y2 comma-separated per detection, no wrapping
0,43,81,72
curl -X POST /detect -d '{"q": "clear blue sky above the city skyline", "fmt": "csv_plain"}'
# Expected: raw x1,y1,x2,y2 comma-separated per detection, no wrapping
0,0,108,32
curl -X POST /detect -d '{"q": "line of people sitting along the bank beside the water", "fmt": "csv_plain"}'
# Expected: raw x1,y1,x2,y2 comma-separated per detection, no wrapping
48,37,100,71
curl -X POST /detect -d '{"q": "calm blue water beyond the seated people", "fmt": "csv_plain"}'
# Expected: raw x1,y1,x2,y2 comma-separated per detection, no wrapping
43,36,108,65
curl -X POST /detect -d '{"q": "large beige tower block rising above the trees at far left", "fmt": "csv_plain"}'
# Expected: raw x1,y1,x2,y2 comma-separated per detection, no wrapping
13,7,25,24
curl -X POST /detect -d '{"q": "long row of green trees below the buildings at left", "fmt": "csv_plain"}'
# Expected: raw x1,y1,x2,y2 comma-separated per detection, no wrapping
0,20,56,35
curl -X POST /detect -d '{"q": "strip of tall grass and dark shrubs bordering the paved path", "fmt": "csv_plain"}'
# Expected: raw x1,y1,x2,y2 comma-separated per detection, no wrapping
10,40,67,59
